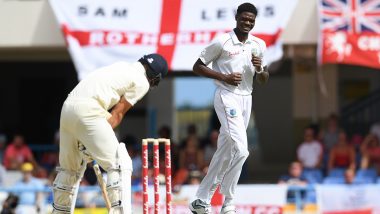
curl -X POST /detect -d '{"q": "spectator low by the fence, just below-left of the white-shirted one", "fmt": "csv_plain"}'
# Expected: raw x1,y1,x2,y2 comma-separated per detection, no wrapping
278,161,307,186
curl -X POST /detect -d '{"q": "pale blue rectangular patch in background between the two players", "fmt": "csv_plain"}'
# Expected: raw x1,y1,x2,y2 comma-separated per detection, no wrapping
174,77,216,107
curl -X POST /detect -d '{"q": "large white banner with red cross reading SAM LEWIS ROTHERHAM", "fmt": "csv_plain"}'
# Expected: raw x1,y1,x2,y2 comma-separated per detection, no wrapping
49,0,298,79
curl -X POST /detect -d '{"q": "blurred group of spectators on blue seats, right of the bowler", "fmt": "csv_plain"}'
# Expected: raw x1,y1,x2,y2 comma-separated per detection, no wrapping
278,114,380,203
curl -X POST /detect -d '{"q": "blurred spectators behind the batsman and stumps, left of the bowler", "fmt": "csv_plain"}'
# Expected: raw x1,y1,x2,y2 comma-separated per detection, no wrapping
0,125,218,214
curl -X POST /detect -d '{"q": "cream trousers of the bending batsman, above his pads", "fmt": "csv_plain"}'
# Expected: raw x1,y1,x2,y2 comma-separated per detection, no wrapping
59,97,119,172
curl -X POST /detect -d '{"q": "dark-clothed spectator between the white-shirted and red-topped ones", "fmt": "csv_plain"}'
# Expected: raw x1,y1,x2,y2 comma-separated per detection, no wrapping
322,114,339,153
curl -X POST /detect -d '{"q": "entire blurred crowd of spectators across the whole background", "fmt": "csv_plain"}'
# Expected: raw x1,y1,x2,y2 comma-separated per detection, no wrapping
0,115,380,213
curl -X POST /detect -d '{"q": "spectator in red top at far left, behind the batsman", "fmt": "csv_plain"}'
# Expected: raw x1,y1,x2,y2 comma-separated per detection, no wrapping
4,134,37,170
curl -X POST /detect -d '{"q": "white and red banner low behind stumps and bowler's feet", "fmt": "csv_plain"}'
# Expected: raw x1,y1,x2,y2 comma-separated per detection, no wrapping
133,185,287,214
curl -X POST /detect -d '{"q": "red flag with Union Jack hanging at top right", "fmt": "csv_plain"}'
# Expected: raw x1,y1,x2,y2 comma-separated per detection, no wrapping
318,0,380,69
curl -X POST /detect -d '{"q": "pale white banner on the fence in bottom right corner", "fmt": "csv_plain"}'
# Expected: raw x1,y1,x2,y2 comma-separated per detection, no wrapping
317,185,380,214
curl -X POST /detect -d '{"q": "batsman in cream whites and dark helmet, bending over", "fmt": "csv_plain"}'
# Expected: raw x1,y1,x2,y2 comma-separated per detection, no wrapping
53,54,168,214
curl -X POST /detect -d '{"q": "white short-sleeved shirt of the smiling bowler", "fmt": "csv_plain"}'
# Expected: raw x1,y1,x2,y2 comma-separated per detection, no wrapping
199,31,266,95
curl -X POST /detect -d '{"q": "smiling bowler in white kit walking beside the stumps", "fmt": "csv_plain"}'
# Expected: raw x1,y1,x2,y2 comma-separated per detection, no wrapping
189,3,269,214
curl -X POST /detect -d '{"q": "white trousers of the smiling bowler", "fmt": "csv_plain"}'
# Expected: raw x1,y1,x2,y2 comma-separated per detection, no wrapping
196,88,252,203
